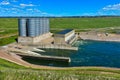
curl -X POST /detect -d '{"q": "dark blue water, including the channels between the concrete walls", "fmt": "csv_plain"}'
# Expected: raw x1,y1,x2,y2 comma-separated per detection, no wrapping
24,41,120,68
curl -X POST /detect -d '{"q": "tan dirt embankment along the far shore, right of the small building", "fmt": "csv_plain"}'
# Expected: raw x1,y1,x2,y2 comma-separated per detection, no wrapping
79,32,120,42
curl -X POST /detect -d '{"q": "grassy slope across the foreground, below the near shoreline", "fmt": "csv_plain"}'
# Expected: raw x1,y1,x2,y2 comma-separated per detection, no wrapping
0,59,120,80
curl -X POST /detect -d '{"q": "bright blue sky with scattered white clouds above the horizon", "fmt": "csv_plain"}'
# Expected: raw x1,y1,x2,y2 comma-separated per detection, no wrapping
0,0,120,16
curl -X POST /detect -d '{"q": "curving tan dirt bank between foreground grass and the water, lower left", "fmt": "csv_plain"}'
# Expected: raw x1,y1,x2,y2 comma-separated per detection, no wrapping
0,50,62,69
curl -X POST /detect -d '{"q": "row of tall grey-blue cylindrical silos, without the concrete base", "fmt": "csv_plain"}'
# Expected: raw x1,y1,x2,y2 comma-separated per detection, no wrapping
18,18,49,37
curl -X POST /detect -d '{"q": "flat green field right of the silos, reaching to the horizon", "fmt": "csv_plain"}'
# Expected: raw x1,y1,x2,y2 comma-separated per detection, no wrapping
50,17,120,29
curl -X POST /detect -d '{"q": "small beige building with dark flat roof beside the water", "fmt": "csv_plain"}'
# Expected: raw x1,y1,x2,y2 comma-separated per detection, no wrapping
54,29,76,44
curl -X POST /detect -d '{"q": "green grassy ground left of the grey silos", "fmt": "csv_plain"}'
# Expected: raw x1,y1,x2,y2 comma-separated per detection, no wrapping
0,18,18,46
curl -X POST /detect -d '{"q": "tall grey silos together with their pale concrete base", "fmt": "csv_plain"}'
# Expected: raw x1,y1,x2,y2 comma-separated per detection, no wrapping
18,17,51,44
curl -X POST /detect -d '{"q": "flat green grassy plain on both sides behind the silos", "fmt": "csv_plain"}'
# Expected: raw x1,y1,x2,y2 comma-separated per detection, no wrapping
0,17,120,46
